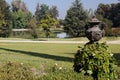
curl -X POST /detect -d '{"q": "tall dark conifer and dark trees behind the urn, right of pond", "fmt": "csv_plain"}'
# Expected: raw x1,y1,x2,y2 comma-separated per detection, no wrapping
64,0,120,37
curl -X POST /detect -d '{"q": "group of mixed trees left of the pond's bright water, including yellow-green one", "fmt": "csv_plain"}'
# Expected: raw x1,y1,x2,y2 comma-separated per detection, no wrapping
0,0,59,38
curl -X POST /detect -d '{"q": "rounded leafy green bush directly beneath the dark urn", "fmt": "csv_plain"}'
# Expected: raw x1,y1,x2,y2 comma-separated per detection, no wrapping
74,43,116,80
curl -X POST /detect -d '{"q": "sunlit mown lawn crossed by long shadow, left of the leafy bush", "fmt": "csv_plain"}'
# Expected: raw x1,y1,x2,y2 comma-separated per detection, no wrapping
0,43,79,67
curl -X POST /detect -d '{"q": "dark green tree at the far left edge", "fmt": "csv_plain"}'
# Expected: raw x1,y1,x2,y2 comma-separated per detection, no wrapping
0,0,11,37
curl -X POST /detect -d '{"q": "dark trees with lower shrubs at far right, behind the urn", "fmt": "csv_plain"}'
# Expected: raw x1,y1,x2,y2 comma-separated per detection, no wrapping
95,3,120,36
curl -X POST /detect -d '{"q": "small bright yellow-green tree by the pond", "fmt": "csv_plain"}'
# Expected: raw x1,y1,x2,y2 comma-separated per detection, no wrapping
40,14,58,37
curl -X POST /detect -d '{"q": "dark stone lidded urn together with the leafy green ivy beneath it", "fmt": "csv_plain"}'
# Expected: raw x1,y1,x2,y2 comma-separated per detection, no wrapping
73,17,116,80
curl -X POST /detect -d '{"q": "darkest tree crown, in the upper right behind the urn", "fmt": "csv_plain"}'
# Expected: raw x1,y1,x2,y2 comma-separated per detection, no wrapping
96,3,120,27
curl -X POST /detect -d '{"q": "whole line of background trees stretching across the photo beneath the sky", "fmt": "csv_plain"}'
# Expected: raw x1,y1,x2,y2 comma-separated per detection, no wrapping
0,0,120,38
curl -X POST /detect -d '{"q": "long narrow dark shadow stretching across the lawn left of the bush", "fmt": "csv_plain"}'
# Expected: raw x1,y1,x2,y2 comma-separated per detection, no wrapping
0,48,73,62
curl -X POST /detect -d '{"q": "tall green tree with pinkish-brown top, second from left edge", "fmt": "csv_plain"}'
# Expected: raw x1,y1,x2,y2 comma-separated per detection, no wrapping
12,0,32,29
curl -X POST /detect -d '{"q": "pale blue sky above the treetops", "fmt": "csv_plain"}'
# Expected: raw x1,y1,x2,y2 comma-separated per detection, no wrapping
6,0,120,19
